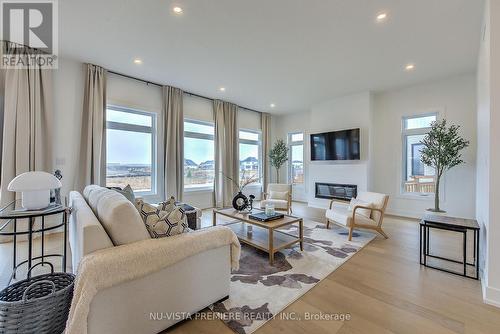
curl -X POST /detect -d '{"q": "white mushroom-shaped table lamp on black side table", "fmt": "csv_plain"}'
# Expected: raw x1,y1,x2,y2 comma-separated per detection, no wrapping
7,172,62,210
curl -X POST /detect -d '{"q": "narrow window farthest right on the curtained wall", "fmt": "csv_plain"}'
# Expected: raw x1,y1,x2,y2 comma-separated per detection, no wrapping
239,130,261,183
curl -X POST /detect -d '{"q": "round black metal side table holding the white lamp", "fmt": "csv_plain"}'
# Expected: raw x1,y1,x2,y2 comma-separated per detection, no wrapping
0,201,71,284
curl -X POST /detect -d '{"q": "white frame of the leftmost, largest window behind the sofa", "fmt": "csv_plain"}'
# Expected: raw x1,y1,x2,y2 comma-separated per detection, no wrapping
105,104,158,197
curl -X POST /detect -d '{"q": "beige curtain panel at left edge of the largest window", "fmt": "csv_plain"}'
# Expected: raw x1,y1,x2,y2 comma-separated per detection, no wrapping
75,64,106,191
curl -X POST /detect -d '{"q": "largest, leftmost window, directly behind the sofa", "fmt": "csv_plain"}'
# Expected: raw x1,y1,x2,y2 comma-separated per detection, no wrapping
106,106,156,195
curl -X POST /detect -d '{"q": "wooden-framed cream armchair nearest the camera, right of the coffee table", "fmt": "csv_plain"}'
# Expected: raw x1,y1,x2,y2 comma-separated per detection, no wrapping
325,192,389,241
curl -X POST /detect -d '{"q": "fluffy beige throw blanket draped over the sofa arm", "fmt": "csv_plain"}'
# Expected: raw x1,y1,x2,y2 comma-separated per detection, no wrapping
65,226,240,334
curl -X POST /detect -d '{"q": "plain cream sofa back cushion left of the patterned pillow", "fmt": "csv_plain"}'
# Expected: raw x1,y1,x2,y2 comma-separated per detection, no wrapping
81,187,150,246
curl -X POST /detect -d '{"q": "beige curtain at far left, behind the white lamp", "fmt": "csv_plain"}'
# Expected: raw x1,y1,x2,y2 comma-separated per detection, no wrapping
0,41,53,207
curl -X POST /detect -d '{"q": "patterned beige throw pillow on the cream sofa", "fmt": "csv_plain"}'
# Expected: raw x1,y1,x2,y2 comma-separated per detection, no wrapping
136,200,190,239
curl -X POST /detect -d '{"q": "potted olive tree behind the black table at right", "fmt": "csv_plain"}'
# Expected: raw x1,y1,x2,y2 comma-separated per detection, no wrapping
420,119,469,212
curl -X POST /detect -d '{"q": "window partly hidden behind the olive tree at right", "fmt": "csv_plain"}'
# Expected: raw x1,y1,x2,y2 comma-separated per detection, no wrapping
403,113,437,195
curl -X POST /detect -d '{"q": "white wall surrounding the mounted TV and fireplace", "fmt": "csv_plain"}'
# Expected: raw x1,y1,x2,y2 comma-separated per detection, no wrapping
271,92,372,207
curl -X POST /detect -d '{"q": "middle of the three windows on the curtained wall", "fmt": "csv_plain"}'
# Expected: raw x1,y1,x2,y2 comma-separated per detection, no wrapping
184,120,215,190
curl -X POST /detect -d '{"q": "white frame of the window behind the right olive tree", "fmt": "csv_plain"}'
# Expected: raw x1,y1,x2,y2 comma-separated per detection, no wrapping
399,110,440,199
